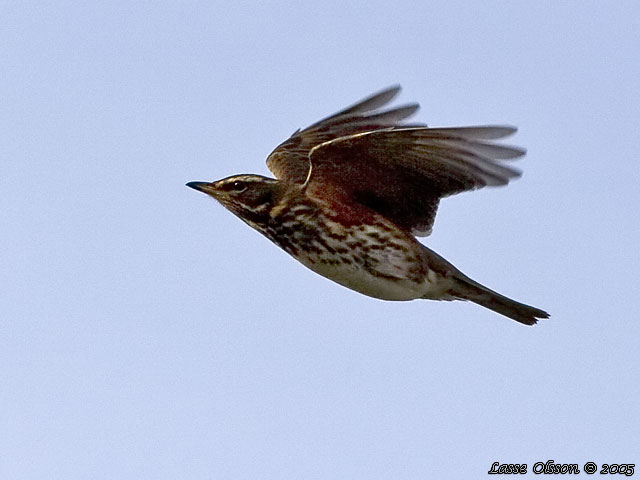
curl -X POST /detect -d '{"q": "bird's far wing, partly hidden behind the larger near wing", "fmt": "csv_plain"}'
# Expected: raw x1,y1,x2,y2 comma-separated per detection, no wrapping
267,86,419,183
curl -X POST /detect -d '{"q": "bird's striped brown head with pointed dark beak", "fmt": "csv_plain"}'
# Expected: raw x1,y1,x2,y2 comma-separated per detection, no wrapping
187,175,282,224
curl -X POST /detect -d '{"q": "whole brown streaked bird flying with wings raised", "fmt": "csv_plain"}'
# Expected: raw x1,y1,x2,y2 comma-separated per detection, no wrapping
186,85,549,325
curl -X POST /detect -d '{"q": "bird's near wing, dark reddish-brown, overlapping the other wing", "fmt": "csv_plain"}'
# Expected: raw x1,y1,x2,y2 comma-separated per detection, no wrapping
305,126,525,236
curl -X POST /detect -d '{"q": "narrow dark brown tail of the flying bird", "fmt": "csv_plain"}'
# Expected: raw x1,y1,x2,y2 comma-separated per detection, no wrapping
452,277,549,325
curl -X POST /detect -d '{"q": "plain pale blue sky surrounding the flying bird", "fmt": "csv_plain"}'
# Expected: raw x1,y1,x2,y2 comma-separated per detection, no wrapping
0,0,640,480
